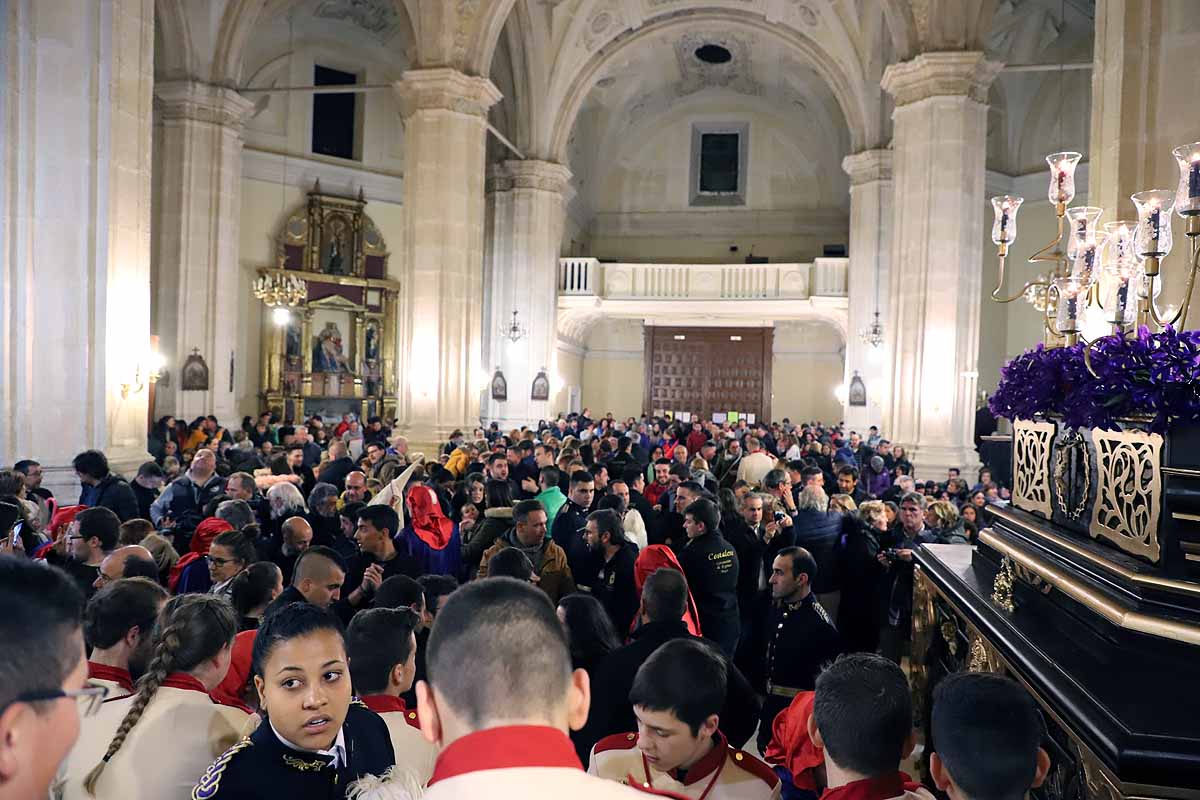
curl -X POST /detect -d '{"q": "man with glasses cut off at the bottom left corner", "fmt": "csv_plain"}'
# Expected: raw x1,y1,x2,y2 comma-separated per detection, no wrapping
0,555,108,800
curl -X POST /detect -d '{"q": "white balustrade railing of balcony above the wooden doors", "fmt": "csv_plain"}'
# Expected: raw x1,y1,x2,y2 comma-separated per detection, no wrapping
558,258,850,300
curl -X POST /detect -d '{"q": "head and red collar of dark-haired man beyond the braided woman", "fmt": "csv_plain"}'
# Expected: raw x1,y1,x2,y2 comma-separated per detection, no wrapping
83,578,169,697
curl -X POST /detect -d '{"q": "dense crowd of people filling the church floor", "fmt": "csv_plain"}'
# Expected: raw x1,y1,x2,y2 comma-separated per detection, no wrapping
0,409,1048,800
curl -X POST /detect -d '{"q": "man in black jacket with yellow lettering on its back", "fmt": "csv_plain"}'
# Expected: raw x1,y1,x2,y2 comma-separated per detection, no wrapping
679,498,742,658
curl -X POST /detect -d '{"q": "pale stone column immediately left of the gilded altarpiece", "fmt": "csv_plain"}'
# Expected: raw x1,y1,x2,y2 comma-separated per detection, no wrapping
154,80,258,425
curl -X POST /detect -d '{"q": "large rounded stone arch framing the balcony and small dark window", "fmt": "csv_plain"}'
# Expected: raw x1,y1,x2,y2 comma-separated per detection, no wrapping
547,8,868,163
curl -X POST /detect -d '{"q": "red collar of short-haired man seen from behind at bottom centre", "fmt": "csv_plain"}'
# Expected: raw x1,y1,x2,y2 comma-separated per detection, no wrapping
428,724,583,786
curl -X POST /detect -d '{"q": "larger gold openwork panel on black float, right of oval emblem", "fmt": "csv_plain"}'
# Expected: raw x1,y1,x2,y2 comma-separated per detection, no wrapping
1088,428,1163,564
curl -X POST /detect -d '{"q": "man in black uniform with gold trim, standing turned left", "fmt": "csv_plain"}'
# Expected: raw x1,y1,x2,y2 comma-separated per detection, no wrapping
750,547,841,752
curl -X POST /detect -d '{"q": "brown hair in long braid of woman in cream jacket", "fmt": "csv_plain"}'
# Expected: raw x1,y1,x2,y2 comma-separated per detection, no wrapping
83,595,238,798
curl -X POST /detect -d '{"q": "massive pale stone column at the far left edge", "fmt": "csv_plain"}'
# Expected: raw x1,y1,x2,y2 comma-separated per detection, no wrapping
0,0,154,505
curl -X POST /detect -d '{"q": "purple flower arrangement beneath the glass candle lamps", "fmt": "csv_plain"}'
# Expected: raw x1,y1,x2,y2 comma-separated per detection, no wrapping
989,327,1200,433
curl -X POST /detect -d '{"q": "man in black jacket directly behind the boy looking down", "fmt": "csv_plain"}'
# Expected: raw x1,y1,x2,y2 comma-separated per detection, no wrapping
588,567,760,750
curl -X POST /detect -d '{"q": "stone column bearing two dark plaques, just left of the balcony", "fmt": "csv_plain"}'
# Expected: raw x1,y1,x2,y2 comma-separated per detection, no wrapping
484,160,571,431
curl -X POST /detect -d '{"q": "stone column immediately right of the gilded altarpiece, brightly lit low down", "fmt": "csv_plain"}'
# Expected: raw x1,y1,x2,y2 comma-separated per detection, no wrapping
395,67,501,446
